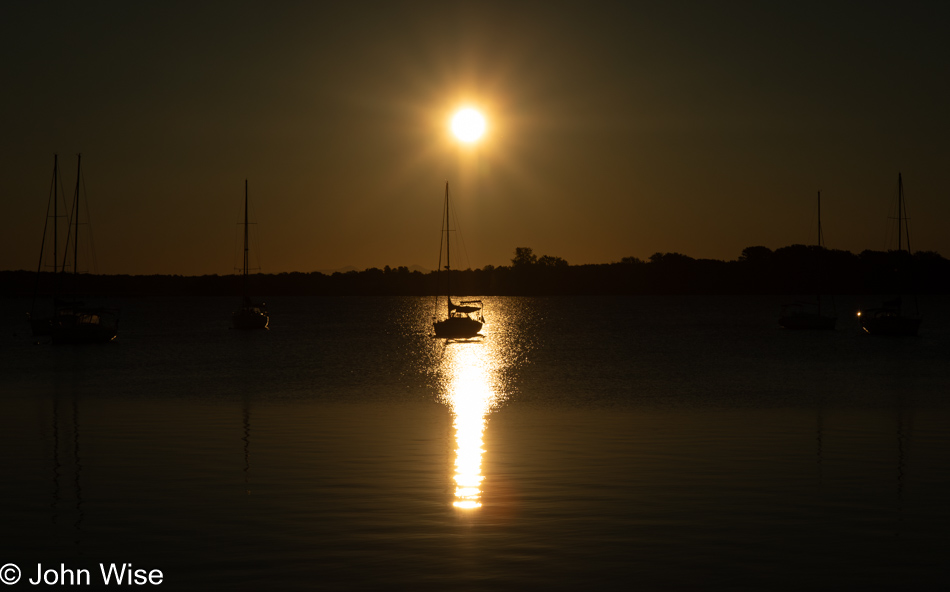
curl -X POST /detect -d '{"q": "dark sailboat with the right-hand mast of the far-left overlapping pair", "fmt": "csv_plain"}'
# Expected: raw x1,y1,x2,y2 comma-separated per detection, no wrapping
50,154,119,344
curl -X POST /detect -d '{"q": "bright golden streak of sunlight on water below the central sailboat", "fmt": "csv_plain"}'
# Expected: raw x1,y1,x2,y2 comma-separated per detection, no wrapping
439,338,505,510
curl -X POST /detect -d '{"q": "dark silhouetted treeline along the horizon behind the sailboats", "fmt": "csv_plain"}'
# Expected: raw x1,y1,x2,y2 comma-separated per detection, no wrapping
0,245,950,297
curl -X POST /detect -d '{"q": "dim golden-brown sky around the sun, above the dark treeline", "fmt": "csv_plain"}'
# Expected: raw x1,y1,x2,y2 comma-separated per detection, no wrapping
0,2,950,275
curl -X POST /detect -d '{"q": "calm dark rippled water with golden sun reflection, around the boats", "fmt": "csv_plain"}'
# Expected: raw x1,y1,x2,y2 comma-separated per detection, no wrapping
0,297,950,590
